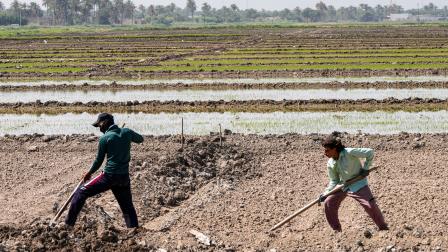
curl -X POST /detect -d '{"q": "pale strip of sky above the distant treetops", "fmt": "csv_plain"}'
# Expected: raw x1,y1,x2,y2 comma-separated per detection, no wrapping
0,0,448,10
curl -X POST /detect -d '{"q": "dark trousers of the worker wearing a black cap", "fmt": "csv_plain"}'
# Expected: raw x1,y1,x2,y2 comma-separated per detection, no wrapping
65,173,138,228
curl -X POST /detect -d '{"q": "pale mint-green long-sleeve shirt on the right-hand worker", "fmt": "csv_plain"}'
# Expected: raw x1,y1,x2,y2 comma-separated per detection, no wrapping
325,148,374,192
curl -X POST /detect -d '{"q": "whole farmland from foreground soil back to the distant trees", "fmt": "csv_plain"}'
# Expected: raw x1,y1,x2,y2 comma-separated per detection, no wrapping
0,23,448,251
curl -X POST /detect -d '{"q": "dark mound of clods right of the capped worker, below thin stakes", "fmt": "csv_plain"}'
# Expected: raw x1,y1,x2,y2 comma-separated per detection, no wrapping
134,139,256,218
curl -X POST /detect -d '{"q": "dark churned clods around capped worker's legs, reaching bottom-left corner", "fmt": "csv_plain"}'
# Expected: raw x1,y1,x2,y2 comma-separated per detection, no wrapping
0,138,256,251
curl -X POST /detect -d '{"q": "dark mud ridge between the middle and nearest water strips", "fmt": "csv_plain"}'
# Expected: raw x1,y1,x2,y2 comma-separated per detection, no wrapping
0,97,448,114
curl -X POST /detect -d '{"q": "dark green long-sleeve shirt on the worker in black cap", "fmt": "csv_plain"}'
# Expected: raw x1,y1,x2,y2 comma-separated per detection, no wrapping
90,125,143,174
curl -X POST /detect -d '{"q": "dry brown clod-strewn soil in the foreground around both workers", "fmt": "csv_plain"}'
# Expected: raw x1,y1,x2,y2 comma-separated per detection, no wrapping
0,132,448,251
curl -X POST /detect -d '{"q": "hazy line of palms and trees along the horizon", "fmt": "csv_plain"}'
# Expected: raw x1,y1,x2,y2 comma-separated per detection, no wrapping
0,0,448,26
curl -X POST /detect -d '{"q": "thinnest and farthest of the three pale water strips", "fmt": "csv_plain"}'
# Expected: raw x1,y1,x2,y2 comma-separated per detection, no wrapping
0,75,448,86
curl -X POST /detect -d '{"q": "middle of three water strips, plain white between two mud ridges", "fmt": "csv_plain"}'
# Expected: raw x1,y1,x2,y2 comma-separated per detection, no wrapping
0,88,448,103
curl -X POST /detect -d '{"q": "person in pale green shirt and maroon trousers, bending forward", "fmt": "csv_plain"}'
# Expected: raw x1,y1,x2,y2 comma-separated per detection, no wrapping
320,135,388,232
